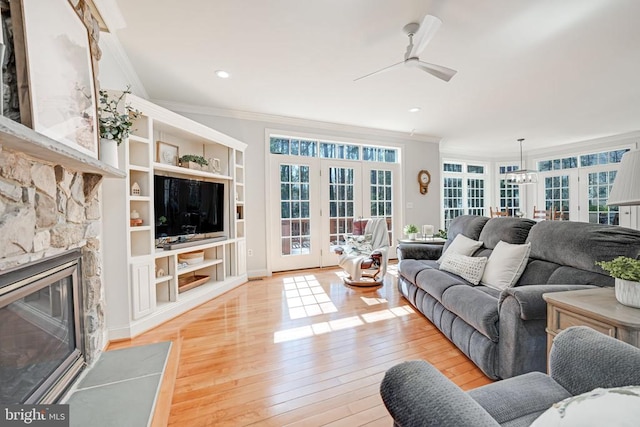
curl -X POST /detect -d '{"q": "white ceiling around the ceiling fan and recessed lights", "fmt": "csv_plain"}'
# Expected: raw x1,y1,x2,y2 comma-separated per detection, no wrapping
102,0,640,154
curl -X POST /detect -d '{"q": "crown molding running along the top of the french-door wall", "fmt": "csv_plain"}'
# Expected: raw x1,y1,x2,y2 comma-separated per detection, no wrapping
153,99,440,144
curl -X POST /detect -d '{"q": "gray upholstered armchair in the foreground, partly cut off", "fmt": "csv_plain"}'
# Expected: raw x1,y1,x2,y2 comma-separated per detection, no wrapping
380,326,640,427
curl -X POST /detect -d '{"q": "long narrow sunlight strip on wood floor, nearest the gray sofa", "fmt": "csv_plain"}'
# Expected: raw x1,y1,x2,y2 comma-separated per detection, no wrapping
273,305,415,344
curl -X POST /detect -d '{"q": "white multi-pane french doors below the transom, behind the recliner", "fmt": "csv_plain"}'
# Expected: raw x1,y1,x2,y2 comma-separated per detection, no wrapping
269,155,399,271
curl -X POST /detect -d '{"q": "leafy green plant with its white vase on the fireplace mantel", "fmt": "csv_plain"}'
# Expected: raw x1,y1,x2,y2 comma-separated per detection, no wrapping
98,86,141,168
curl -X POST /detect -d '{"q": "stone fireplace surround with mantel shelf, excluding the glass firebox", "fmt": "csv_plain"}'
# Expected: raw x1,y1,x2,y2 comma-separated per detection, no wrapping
0,117,125,365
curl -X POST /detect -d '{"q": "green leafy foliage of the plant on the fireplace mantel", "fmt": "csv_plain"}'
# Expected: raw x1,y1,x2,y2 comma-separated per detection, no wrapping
98,86,142,145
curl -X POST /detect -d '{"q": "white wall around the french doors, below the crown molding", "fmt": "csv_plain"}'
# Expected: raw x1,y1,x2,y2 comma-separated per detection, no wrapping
165,110,440,277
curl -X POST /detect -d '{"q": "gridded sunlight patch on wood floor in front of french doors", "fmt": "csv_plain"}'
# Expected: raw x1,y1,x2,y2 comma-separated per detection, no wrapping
283,275,338,319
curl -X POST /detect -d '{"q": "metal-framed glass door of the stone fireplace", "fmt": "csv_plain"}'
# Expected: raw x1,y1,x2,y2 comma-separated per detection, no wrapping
0,256,82,404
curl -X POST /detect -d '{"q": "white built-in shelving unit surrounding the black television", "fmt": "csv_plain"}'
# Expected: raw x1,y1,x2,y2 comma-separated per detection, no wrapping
102,95,247,340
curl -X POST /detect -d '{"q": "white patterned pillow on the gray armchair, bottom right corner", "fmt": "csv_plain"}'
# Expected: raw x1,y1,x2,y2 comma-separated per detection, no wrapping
531,386,640,427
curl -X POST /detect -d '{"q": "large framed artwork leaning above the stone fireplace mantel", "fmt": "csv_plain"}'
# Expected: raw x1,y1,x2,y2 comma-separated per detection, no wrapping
11,0,98,158
